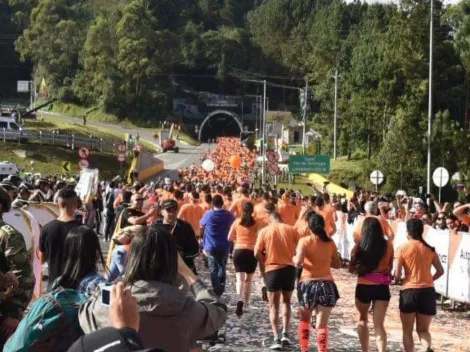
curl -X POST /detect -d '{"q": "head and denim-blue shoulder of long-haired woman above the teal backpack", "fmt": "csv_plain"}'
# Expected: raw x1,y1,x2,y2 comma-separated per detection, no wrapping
52,225,107,296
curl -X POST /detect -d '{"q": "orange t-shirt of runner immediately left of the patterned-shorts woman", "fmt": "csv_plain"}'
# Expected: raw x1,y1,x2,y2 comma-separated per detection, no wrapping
255,224,299,272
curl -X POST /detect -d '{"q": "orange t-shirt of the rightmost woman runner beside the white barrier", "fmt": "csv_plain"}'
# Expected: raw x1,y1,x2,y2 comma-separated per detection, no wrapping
397,240,435,290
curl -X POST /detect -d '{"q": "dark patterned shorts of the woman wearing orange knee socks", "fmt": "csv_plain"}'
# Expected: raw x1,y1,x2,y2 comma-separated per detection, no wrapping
297,280,339,310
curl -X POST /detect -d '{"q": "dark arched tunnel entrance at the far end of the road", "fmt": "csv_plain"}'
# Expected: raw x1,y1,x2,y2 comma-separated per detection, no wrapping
199,111,242,142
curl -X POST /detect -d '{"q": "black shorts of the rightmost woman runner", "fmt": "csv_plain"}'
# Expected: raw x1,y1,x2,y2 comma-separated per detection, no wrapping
400,287,436,316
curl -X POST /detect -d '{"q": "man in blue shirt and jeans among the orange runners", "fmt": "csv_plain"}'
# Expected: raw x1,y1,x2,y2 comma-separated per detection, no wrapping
201,195,235,296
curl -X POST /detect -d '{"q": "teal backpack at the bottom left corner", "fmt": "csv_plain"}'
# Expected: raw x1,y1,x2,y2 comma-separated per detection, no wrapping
3,287,87,352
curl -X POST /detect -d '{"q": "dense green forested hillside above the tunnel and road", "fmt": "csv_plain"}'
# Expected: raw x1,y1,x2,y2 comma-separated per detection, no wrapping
0,0,470,190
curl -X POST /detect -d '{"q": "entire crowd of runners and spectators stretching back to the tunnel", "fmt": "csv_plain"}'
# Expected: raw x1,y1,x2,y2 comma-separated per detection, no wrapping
0,138,464,352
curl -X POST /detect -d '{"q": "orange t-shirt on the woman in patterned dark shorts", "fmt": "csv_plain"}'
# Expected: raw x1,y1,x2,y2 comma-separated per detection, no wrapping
297,235,339,282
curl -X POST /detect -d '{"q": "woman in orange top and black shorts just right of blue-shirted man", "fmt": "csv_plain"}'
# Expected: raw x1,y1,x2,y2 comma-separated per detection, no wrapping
228,202,259,317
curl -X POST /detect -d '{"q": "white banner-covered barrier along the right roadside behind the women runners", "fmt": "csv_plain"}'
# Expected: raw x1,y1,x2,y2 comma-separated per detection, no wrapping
333,212,470,303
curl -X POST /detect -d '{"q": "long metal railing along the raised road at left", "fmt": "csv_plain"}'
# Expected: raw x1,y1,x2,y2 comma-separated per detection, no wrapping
0,128,123,153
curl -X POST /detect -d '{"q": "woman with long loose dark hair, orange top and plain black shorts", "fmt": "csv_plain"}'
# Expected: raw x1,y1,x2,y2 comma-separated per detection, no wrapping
349,217,394,352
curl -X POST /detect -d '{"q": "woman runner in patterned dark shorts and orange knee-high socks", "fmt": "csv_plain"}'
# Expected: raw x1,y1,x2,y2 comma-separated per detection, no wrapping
293,214,341,352
